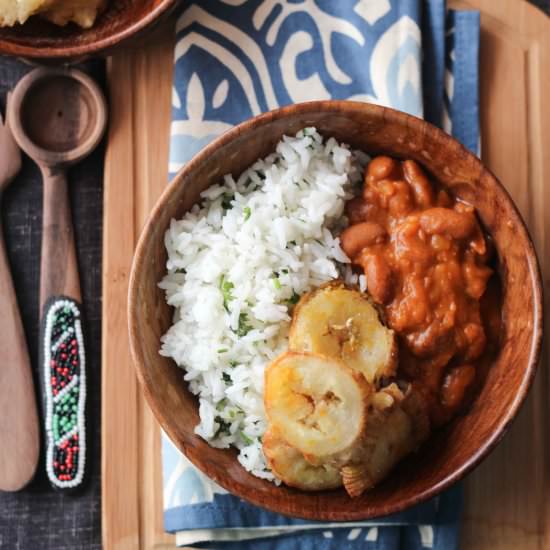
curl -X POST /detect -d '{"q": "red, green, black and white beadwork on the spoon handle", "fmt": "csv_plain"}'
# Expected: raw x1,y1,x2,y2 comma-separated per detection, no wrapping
44,298,86,489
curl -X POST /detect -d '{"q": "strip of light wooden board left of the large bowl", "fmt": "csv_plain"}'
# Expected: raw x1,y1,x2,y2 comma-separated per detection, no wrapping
102,25,174,550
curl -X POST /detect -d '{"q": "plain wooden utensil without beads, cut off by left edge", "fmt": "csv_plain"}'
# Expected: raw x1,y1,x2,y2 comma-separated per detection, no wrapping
0,94,40,491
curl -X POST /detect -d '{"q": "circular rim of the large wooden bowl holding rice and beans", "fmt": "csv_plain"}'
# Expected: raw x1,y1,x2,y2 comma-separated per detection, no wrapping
128,100,544,521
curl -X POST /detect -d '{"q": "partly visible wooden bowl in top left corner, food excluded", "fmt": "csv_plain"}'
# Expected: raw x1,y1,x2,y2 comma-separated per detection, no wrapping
0,0,176,60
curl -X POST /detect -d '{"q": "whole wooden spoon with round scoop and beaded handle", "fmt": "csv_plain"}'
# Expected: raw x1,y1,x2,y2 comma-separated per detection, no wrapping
9,68,107,496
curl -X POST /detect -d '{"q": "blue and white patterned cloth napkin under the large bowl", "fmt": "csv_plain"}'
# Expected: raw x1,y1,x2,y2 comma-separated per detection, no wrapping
162,0,479,550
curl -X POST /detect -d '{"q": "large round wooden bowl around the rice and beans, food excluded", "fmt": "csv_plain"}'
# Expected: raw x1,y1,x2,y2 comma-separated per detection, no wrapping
129,101,543,521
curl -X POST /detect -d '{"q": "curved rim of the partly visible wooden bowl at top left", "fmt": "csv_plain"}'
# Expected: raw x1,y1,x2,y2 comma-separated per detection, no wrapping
0,0,177,59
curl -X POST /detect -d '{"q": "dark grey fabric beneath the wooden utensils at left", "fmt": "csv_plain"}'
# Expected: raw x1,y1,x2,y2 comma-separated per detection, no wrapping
0,58,104,550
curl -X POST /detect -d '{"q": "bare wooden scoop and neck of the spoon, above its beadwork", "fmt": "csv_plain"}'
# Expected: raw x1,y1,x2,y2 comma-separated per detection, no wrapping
8,68,107,313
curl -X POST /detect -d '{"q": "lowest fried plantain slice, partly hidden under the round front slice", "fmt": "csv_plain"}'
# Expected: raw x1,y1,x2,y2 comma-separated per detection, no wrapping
262,426,342,491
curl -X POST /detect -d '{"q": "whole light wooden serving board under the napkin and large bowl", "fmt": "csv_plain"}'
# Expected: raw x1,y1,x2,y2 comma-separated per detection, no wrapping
102,0,550,550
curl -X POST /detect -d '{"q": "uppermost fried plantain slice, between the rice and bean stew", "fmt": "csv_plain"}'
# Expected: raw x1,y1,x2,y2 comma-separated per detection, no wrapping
289,282,397,383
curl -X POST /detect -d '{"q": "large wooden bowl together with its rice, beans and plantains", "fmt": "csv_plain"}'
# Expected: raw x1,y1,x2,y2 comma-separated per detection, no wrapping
129,102,541,520
